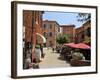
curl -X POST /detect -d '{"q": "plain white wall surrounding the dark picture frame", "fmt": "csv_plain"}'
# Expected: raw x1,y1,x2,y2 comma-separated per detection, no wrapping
0,0,100,80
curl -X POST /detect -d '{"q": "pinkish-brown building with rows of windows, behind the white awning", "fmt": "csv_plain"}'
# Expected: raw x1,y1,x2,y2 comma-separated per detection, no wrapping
43,20,60,47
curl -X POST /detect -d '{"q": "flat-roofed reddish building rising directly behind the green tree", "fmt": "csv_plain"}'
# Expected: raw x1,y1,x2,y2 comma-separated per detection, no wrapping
61,25,75,42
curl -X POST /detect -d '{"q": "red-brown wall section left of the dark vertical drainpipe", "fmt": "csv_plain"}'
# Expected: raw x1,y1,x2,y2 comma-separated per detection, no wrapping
23,11,32,42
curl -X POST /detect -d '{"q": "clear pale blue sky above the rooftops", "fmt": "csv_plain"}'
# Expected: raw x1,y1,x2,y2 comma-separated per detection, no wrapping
43,11,83,28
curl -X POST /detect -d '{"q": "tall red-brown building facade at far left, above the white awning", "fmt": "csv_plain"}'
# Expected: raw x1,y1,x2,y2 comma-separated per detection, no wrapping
23,10,43,60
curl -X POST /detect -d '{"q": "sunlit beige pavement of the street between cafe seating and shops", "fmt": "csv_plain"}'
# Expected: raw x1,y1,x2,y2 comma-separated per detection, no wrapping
39,48,70,68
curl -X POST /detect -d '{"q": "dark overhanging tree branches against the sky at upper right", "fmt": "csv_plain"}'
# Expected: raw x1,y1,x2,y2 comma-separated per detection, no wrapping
77,13,91,22
